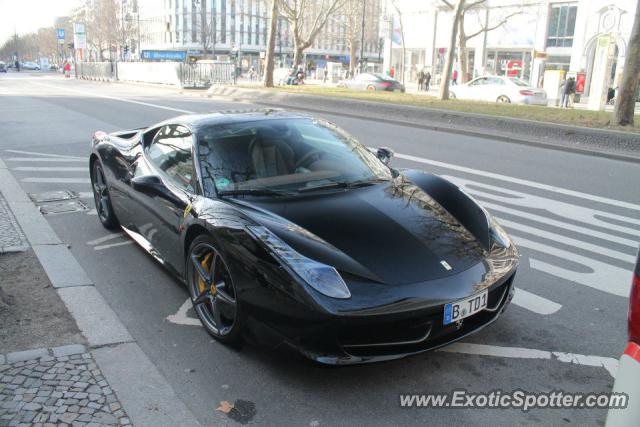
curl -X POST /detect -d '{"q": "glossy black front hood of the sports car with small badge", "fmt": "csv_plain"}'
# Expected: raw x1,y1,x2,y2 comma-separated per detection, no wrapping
234,180,485,285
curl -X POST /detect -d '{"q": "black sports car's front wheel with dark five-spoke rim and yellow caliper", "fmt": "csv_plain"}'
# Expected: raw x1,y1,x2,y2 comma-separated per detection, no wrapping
185,234,246,348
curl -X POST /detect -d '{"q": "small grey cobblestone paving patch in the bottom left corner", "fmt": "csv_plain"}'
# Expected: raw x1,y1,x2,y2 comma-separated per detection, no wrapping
0,344,131,427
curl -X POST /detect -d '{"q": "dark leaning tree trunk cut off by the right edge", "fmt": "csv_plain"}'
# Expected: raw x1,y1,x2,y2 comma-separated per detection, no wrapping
613,0,640,126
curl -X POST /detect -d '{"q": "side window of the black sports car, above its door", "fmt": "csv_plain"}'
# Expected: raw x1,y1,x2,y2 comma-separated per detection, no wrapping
147,125,193,191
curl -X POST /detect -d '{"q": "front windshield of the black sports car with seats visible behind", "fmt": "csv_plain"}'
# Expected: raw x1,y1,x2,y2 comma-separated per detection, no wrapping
198,118,391,196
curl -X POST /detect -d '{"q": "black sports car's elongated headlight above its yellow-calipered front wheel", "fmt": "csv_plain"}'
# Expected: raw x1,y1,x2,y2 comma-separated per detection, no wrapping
246,225,351,299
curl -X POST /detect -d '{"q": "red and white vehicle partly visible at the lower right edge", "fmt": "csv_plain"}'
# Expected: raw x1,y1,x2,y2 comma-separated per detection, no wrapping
607,252,640,427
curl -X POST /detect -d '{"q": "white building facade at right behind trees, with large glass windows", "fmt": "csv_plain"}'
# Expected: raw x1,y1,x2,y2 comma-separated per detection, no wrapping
382,0,636,101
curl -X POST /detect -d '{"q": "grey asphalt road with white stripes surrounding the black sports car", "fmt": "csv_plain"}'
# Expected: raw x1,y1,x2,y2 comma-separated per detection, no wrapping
0,74,640,426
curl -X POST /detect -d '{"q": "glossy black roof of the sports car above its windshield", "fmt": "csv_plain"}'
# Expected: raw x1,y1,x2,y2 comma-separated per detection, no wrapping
158,108,311,131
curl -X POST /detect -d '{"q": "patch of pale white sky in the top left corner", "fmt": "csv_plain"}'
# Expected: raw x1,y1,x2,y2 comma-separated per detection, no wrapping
0,0,78,44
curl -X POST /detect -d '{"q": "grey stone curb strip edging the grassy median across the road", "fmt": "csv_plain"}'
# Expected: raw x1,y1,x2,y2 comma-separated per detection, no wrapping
202,86,640,163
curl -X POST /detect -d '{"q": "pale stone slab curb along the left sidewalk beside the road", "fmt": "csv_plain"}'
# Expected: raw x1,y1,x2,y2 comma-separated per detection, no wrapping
0,159,200,426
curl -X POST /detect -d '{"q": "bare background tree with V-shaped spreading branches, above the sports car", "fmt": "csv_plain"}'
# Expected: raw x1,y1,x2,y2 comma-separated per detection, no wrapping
280,0,343,67
